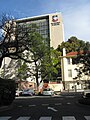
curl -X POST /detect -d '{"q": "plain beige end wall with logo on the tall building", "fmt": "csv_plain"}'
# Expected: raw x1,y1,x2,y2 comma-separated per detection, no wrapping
49,13,64,49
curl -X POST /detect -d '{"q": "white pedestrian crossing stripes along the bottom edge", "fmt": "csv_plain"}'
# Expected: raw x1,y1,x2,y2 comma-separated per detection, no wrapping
0,116,90,120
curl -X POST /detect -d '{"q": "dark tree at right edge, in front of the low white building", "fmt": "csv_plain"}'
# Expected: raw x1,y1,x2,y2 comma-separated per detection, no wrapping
74,42,90,80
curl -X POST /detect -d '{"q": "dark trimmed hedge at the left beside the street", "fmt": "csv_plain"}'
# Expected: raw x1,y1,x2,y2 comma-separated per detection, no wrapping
0,78,16,105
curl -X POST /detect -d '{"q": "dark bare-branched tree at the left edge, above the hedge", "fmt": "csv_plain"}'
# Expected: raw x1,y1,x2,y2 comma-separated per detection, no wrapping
0,15,30,67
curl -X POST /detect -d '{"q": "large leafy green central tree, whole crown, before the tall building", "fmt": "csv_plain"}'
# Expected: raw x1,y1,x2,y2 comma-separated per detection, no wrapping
15,30,60,86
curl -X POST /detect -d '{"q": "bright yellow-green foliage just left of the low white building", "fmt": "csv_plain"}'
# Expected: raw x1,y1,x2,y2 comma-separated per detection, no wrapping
42,48,60,81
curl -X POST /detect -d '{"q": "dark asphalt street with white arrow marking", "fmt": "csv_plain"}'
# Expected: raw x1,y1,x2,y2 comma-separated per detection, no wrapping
0,95,90,120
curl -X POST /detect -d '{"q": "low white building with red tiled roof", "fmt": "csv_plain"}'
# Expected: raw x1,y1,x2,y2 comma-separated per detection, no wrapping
61,49,90,91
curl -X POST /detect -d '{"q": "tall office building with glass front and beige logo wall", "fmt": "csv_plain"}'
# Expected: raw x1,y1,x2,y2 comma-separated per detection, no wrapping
16,13,64,49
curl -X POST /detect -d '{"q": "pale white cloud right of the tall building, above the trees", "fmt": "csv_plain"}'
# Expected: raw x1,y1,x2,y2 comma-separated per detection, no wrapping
63,5,90,41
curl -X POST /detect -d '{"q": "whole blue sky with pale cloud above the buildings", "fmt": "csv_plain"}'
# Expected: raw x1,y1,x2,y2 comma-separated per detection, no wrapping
0,0,90,42
